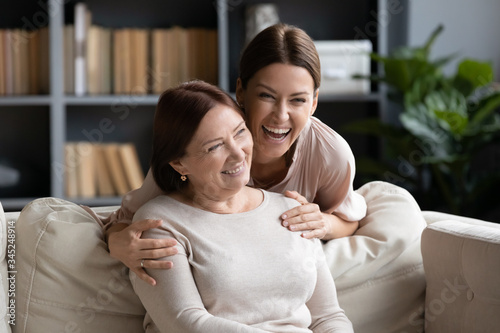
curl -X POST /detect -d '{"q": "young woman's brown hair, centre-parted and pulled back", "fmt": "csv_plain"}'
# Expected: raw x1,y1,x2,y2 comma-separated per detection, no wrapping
239,23,321,90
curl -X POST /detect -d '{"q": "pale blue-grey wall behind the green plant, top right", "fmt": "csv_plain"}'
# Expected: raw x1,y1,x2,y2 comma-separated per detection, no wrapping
408,0,500,81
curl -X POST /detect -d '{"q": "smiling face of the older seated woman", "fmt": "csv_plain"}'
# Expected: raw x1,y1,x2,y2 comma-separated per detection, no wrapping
179,105,253,196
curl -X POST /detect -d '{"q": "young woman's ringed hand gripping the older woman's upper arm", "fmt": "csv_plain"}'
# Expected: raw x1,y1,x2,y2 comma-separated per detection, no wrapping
107,220,177,286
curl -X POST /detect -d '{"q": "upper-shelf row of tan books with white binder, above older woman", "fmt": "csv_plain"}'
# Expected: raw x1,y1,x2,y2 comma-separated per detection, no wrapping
64,3,218,96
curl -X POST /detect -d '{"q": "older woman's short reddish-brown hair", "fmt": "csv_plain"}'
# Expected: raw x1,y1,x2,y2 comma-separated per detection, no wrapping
151,81,243,192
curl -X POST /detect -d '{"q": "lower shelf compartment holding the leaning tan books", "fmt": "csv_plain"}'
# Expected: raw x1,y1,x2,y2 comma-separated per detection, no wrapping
64,105,155,200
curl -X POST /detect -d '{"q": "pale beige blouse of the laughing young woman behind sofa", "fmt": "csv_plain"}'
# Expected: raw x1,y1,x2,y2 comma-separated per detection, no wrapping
103,117,366,226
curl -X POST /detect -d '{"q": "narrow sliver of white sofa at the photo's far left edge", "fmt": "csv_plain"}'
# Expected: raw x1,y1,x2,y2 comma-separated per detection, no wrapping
0,203,15,333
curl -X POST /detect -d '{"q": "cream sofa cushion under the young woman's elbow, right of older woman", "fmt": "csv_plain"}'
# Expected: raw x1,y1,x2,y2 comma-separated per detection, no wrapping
323,182,426,333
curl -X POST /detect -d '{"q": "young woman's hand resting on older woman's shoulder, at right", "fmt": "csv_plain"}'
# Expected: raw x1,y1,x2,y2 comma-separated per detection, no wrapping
281,191,359,240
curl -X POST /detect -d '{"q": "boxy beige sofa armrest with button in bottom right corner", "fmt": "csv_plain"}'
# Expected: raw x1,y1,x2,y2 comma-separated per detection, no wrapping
421,220,500,333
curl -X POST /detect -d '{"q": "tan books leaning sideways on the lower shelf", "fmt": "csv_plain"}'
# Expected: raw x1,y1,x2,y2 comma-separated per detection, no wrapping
64,141,144,198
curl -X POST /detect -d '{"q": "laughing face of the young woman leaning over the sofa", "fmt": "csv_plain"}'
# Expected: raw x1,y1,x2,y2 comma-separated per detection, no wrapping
236,63,318,163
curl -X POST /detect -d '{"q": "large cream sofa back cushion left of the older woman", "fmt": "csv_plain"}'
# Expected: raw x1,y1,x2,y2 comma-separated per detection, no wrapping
15,198,145,333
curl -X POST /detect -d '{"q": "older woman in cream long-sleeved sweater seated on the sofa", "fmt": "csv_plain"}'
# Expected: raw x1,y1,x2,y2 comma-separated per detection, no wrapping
131,82,352,333
